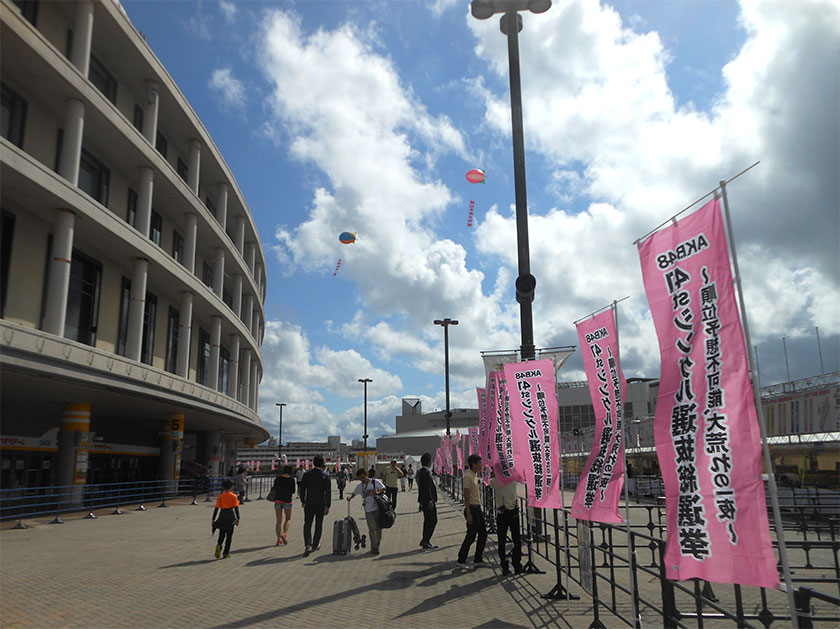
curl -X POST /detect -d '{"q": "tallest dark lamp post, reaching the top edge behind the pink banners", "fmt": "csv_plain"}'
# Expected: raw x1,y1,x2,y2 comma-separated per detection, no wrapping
471,0,551,360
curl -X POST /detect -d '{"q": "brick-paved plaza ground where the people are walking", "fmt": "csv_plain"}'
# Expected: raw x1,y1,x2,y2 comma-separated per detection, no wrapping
0,484,600,628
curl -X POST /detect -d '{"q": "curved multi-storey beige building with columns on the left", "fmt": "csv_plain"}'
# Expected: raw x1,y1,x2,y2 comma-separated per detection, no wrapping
0,0,268,487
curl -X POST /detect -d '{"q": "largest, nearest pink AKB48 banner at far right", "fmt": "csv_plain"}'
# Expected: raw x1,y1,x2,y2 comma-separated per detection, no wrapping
639,199,779,587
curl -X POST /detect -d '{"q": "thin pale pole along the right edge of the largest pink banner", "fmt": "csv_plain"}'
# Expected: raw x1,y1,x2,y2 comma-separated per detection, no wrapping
720,181,799,629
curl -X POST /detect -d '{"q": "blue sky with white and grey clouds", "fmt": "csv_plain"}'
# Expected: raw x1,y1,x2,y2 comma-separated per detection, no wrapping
118,0,840,443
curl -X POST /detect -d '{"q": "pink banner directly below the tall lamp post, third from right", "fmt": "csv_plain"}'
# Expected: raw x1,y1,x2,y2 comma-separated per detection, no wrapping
504,359,563,509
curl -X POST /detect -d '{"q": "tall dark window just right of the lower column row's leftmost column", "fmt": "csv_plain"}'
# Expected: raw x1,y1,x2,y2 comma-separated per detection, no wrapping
64,249,102,345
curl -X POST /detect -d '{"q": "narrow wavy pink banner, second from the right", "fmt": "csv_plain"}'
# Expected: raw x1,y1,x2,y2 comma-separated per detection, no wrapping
572,308,627,523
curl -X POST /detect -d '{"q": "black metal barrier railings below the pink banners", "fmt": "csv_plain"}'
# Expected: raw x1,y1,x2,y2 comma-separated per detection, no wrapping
438,474,840,628
